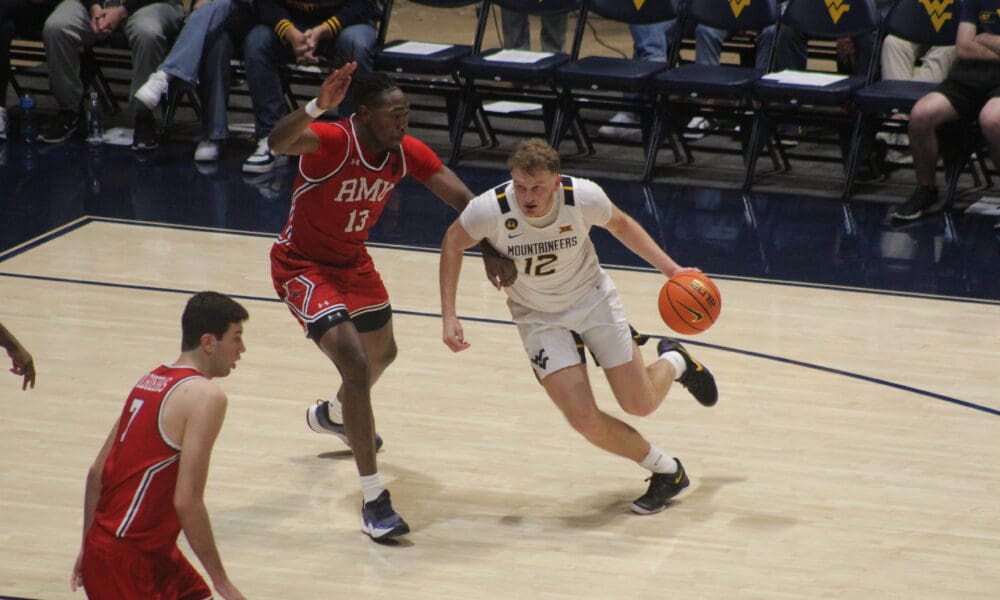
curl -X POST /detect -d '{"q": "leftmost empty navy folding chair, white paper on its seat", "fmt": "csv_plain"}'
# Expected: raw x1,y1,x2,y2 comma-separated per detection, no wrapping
375,0,496,152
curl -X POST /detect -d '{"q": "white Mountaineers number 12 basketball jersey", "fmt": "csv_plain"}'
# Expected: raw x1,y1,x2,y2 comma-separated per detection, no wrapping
459,176,614,320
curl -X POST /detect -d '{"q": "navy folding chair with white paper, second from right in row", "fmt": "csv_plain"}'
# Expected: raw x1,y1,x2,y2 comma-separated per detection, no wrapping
743,0,881,191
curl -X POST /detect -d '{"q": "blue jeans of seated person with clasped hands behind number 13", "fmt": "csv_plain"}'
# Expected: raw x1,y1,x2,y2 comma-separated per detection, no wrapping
243,23,377,139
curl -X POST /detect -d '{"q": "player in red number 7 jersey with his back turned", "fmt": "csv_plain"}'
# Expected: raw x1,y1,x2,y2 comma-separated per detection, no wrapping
70,292,249,600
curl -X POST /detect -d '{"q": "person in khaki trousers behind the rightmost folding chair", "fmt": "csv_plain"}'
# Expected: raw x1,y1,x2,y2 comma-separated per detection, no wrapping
876,34,957,164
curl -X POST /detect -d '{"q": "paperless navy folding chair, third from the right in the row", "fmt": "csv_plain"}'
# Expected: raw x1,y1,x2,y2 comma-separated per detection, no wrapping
643,0,778,181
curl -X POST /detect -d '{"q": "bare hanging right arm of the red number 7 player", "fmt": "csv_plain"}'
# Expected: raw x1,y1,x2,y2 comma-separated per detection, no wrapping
171,379,244,600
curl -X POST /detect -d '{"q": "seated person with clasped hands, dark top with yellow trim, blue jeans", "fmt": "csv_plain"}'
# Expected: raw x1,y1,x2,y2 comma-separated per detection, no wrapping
243,0,380,173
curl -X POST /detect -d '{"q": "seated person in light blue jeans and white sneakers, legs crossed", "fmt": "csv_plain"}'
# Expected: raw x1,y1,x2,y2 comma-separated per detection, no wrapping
135,0,254,162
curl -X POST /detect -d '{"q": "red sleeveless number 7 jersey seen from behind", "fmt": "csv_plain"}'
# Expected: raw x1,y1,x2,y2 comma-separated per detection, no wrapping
94,365,204,552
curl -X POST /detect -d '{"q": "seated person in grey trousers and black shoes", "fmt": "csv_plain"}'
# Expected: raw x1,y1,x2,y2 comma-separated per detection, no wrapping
39,0,184,151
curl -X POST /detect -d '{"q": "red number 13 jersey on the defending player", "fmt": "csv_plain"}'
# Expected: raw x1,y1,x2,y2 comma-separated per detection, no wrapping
277,115,442,266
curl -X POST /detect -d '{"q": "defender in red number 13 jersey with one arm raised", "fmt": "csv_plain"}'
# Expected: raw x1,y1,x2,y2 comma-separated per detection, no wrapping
268,63,516,541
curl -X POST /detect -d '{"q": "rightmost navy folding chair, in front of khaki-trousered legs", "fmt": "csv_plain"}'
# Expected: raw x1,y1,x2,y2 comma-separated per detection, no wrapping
842,0,989,206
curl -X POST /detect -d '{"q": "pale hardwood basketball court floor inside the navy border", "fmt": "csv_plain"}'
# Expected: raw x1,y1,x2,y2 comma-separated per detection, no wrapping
0,218,1000,600
